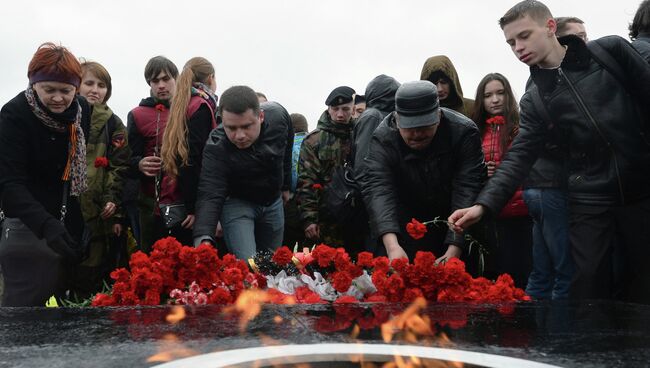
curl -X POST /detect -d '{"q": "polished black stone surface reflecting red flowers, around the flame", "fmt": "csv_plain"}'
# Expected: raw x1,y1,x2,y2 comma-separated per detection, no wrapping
0,301,650,367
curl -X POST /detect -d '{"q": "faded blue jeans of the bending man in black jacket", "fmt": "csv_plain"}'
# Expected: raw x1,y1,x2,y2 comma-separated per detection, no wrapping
221,197,284,259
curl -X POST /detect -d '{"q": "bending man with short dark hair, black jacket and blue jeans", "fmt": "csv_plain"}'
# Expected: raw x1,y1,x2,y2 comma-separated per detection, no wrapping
194,86,293,259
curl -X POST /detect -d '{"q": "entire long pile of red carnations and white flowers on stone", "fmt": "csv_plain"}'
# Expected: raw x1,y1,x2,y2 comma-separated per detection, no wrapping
92,237,530,306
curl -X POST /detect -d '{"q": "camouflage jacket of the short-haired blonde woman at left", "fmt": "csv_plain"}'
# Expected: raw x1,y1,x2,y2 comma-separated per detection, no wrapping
81,105,131,221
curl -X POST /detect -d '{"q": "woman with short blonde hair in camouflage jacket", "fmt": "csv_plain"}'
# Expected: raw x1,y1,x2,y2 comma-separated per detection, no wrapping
73,61,131,298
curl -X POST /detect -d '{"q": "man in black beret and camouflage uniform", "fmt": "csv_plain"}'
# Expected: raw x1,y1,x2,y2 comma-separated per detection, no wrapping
296,86,360,246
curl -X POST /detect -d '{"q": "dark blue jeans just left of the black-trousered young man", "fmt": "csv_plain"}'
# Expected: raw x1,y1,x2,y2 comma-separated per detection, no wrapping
524,188,574,299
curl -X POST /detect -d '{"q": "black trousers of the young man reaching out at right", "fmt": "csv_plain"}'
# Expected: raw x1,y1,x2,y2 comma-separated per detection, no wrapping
569,198,650,304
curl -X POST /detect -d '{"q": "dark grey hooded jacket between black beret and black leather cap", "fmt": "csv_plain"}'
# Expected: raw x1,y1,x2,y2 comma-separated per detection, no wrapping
352,74,400,167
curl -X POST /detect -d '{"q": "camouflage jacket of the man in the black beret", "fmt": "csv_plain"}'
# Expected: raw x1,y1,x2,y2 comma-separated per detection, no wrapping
296,111,356,228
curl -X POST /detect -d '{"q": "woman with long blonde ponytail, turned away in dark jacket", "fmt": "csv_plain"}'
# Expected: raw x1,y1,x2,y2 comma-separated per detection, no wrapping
157,57,217,245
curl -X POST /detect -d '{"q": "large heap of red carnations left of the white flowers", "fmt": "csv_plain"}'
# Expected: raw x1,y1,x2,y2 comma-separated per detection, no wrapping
92,237,265,306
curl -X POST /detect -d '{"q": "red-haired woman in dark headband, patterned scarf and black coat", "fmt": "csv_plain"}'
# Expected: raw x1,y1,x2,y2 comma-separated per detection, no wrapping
0,43,90,306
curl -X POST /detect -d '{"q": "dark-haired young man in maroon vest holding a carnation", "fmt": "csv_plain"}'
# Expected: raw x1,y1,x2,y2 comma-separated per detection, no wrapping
125,56,178,252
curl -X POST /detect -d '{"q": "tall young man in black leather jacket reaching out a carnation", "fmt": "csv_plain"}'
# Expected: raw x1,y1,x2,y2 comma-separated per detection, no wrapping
449,0,650,303
